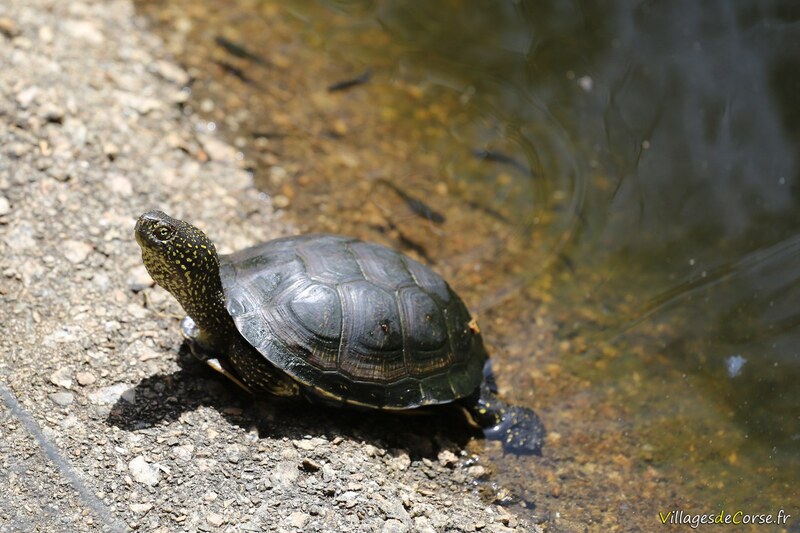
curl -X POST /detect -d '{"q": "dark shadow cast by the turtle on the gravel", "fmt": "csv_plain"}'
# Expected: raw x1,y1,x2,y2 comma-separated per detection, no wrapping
106,345,481,459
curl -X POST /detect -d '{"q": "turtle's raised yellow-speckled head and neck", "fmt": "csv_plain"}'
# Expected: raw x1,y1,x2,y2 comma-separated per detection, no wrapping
135,211,233,352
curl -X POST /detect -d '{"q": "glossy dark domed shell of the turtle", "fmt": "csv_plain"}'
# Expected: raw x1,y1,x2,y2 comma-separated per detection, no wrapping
220,235,487,409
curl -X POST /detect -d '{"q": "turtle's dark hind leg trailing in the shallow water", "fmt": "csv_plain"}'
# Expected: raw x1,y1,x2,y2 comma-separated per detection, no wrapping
463,383,545,455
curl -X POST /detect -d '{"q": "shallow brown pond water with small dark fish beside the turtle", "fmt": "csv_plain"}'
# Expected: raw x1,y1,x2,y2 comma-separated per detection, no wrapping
134,0,800,530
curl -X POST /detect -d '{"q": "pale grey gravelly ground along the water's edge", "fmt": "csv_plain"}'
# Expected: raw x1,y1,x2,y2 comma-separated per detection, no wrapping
0,0,538,532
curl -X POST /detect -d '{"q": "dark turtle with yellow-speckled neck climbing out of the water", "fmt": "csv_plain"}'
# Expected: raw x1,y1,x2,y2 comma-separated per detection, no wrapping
135,210,545,455
